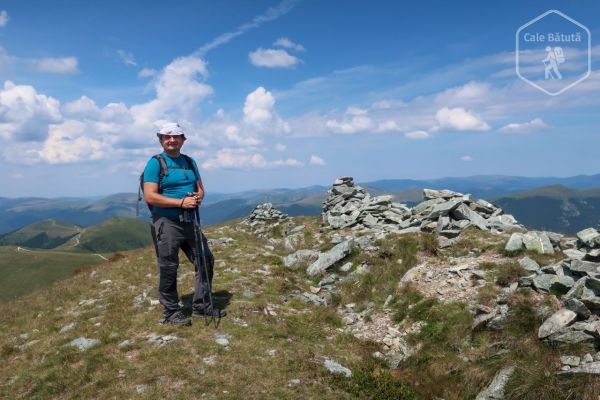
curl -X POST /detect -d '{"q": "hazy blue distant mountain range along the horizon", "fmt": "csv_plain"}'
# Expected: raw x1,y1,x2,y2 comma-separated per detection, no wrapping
0,174,600,236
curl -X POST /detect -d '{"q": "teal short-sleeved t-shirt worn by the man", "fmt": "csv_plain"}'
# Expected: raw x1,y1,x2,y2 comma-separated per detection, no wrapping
144,152,201,220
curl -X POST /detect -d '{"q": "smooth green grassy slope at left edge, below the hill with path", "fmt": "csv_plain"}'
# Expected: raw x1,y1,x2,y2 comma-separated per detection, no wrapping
0,246,103,301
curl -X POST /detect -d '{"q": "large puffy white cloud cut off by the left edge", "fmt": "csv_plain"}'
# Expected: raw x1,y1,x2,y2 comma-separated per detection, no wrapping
0,81,62,141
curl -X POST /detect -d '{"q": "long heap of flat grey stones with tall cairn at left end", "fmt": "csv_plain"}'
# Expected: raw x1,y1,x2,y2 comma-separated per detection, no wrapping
321,176,523,238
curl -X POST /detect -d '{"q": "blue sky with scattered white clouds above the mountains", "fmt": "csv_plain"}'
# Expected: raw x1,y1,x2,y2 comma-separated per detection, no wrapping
0,0,600,197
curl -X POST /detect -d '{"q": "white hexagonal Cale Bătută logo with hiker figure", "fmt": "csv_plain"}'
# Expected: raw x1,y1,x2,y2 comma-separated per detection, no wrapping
515,10,592,96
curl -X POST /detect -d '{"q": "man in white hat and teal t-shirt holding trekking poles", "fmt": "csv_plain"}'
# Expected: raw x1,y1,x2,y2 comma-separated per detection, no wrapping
144,123,226,325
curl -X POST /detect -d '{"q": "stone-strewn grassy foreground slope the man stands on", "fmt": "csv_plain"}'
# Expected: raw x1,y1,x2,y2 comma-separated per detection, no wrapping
0,218,600,400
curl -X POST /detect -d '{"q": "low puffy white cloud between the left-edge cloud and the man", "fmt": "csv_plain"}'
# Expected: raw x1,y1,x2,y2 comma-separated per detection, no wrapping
38,120,107,164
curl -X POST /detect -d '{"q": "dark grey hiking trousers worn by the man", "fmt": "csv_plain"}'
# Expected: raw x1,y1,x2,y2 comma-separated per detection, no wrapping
151,216,215,318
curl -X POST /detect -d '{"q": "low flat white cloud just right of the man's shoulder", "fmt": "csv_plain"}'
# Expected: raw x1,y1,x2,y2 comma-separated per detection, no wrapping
202,149,304,170
